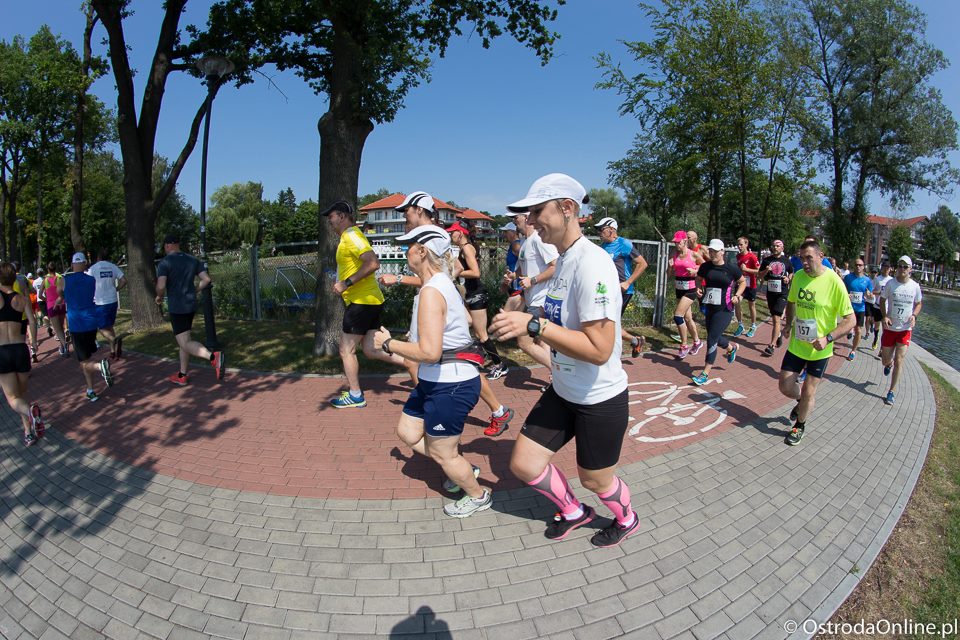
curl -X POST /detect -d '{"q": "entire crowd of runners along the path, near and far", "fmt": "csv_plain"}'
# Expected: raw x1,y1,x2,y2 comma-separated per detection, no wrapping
0,173,922,547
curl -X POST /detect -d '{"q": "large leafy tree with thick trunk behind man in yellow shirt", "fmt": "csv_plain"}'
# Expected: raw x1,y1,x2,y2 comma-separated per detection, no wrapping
199,0,563,355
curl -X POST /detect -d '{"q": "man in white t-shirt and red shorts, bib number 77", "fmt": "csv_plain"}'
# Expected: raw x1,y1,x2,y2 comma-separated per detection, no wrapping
880,256,923,404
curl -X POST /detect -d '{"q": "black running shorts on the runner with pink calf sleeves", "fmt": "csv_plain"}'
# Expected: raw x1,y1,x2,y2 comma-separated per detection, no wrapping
520,386,630,470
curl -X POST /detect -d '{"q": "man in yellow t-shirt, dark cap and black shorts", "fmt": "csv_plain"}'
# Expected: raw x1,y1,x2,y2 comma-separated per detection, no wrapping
322,200,403,409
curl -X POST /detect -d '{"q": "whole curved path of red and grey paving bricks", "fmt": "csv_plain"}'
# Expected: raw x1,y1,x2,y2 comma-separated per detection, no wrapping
0,328,934,640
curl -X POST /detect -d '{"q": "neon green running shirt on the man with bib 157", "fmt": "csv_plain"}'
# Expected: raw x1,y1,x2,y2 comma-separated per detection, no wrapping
787,269,853,360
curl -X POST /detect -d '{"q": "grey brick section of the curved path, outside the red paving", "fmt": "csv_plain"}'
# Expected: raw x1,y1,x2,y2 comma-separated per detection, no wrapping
0,338,935,640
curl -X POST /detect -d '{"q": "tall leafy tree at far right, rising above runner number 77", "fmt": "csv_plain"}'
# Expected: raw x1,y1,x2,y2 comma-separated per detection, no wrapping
797,0,957,260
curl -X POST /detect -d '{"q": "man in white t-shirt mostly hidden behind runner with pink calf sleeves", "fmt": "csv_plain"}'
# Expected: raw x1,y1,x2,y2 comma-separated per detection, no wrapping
504,212,560,367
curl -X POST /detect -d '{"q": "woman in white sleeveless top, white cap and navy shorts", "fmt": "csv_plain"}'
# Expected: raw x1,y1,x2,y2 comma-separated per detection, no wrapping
374,225,493,518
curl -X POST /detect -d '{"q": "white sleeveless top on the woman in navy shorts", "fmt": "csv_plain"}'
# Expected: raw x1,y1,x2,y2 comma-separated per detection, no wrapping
410,273,480,382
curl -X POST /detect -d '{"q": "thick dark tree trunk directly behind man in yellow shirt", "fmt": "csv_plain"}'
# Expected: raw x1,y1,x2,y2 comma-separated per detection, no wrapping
313,109,373,356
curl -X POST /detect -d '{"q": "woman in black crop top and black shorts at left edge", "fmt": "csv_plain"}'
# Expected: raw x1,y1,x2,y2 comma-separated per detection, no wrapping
0,262,43,447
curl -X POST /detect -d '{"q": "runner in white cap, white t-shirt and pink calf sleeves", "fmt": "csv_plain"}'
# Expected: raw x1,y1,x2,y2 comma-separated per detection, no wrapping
490,173,640,547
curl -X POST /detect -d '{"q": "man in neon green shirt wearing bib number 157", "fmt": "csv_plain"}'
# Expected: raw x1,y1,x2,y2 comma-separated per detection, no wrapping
779,240,856,445
